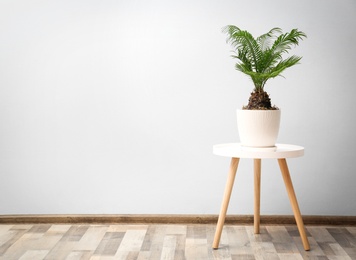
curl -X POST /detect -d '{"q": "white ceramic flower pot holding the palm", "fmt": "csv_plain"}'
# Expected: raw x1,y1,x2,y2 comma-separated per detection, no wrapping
237,109,281,147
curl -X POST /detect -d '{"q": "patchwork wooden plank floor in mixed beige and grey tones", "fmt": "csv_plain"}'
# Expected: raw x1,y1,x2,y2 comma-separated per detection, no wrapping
0,224,356,260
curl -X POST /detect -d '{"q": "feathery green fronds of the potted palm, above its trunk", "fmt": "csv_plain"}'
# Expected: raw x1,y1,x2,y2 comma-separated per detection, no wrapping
223,25,306,90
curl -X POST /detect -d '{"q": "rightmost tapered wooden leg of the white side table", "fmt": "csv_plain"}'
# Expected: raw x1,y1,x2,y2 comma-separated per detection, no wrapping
278,159,310,251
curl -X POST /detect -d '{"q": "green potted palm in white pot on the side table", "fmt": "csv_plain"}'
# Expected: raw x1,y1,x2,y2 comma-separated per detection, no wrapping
223,25,306,148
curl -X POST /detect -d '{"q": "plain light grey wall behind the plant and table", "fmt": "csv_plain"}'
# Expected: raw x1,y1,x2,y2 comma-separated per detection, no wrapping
0,0,356,215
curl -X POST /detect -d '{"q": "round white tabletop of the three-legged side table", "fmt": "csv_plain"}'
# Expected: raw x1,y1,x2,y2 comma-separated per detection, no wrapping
213,143,304,159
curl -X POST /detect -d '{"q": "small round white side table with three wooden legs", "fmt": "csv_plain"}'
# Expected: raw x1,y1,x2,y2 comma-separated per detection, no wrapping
213,143,310,251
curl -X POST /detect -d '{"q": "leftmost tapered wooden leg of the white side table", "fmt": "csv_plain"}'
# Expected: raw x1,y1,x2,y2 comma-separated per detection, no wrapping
213,158,240,249
